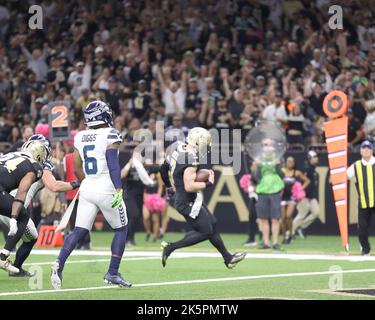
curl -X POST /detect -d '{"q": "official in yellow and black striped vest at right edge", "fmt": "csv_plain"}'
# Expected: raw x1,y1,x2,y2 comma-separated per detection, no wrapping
347,140,375,255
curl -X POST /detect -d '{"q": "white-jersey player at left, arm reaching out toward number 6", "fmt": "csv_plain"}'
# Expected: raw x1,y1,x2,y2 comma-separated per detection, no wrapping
0,134,80,277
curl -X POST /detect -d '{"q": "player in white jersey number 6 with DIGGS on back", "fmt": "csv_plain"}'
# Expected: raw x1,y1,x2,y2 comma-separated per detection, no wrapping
51,101,131,289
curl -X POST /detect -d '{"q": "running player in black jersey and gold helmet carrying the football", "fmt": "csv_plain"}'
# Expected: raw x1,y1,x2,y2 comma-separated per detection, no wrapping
161,127,246,269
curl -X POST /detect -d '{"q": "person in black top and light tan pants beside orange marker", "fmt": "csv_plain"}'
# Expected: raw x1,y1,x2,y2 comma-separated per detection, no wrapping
293,150,320,238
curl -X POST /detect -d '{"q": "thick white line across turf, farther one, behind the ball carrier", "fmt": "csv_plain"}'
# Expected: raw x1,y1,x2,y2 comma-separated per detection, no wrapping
27,250,375,262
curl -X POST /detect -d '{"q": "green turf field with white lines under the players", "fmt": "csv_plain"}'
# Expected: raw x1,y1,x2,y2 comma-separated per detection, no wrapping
0,232,375,300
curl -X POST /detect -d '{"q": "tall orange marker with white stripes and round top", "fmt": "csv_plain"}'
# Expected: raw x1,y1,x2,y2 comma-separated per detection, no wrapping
323,90,349,252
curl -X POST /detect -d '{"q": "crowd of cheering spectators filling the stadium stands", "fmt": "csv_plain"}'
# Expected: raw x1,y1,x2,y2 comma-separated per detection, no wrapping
0,0,375,153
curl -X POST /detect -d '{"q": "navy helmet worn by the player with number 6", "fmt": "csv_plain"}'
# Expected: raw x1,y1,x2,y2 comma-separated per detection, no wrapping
83,100,113,127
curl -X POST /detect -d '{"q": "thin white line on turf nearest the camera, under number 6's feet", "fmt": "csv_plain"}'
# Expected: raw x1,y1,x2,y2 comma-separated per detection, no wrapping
0,269,375,297
